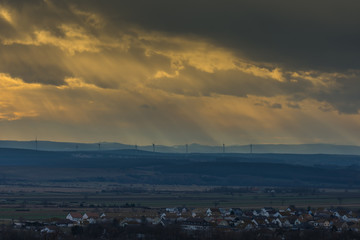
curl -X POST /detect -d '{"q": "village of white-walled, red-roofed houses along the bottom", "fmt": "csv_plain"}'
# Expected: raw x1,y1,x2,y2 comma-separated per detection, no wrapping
4,206,360,238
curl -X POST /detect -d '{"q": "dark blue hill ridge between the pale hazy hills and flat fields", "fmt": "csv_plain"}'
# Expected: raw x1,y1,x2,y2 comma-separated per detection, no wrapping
0,148,360,189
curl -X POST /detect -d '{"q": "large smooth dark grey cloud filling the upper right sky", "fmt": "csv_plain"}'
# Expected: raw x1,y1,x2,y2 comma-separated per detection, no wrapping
69,0,360,71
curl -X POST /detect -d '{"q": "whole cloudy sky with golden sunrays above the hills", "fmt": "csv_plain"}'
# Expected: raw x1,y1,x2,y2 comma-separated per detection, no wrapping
0,0,360,145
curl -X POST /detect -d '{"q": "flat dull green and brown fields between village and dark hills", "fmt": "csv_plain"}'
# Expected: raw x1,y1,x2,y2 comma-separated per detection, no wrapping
0,183,360,220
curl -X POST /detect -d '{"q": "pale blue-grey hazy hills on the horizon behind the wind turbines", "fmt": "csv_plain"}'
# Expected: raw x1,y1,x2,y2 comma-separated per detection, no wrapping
0,140,360,155
